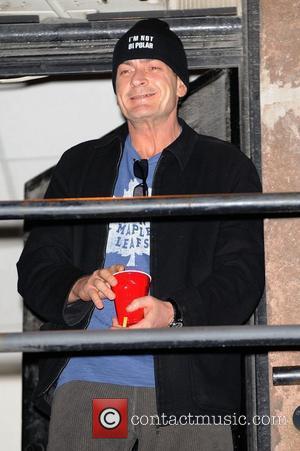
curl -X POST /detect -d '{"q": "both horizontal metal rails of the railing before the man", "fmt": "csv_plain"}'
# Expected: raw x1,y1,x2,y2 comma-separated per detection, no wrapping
0,193,300,352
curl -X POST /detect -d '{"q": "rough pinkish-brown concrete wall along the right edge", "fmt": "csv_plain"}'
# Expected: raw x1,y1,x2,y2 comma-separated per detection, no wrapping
261,0,300,451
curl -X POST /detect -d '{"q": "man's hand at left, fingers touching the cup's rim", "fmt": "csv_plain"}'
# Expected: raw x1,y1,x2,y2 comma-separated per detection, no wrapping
68,264,125,309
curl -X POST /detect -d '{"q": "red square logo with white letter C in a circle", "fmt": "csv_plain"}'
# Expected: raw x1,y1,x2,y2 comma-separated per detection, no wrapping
93,398,128,438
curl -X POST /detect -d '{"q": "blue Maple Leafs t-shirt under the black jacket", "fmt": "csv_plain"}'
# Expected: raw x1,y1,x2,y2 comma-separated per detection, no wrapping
57,136,161,387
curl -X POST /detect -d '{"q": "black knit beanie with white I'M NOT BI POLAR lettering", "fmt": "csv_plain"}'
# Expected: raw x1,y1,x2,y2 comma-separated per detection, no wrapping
112,19,189,92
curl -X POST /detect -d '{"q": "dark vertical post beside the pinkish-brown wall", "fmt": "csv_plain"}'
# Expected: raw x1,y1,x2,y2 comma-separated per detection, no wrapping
240,0,271,451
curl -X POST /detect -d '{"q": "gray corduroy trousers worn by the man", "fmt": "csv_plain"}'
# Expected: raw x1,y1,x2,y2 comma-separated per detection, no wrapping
47,381,233,451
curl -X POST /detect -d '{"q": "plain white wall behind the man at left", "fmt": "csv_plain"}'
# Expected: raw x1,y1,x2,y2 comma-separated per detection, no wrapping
0,79,122,451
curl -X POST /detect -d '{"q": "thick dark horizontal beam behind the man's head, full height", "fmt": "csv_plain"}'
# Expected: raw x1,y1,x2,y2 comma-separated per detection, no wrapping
0,15,242,77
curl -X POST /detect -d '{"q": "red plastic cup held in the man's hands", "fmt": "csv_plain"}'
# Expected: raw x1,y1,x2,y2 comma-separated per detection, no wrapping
112,270,151,327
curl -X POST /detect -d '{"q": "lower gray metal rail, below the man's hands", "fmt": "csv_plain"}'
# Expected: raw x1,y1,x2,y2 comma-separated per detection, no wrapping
0,325,300,352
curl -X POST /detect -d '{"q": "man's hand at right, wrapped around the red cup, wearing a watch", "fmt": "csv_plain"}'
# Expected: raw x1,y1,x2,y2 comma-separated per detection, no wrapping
112,296,174,329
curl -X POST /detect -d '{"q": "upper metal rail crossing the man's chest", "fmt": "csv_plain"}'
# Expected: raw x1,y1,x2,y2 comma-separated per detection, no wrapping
0,193,300,220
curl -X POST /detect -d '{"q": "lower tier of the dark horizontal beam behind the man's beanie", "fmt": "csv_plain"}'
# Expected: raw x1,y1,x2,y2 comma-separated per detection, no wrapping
0,50,242,78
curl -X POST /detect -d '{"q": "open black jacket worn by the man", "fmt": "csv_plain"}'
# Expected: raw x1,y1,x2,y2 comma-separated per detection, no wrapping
17,121,264,415
